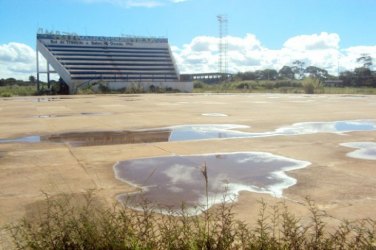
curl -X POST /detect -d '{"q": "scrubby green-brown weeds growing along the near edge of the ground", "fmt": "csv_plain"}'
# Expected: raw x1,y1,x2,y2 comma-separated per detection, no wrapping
7,192,376,249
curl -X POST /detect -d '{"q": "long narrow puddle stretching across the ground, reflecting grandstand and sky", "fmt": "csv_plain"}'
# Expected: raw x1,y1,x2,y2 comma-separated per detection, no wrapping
0,120,376,146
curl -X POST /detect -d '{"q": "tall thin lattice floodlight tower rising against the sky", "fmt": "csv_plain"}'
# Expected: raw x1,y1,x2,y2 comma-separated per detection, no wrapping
217,15,228,78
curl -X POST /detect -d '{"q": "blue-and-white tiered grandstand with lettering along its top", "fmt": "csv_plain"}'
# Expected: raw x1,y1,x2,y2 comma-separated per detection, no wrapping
37,34,193,93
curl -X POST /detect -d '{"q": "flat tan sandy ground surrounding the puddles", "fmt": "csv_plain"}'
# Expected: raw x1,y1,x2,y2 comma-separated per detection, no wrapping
0,94,376,243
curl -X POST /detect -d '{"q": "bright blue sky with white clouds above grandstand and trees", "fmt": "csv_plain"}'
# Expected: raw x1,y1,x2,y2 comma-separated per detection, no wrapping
0,0,376,79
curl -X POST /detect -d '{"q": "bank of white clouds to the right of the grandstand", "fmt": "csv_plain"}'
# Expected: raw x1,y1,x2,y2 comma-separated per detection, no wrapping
173,32,376,75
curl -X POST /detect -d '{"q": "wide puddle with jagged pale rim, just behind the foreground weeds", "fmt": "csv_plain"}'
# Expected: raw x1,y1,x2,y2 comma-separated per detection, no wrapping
114,152,310,213
